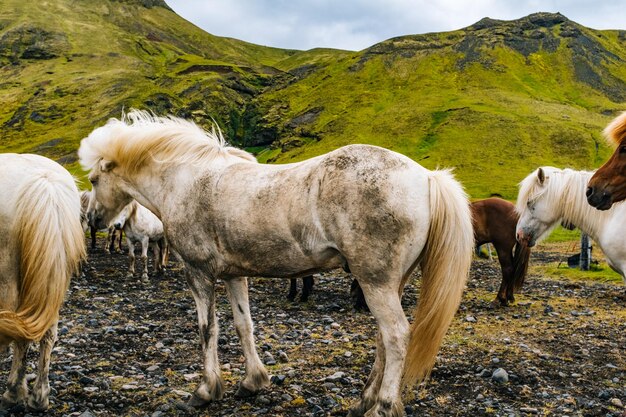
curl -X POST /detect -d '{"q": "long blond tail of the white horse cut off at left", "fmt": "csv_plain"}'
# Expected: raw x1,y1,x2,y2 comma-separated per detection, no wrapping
0,172,85,341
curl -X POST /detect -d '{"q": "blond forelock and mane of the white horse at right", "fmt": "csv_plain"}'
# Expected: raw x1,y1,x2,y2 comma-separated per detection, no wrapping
516,167,612,239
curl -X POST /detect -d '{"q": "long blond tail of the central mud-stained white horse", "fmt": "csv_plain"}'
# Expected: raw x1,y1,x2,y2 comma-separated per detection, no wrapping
403,170,474,386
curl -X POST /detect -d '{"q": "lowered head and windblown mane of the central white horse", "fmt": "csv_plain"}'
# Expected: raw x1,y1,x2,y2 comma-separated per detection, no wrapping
78,110,256,224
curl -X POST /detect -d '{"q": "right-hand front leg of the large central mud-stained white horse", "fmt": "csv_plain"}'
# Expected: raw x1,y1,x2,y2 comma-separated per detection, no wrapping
225,277,270,397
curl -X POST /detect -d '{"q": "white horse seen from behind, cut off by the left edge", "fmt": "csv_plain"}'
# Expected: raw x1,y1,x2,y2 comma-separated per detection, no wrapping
0,154,85,410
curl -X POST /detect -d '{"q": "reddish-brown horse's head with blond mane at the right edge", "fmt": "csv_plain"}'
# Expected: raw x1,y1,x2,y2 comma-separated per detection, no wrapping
587,112,626,210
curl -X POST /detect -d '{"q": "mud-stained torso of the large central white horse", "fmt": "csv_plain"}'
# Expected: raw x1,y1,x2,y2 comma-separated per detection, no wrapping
166,145,429,276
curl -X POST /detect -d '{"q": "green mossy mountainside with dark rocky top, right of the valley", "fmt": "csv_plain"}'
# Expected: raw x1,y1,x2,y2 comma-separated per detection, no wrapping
252,13,626,199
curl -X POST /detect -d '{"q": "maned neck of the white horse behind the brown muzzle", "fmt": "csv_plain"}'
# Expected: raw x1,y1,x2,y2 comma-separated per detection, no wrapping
559,171,607,239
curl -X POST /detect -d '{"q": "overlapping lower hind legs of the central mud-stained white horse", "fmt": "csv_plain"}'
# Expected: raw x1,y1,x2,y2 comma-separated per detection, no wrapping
349,278,409,417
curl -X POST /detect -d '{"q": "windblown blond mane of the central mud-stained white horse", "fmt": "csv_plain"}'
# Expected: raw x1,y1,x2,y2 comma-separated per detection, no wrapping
78,110,256,173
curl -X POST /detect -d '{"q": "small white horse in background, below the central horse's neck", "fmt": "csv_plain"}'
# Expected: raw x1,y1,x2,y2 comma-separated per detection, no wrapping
112,201,167,282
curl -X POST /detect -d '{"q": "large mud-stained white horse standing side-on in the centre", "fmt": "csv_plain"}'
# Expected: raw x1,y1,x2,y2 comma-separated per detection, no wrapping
79,111,474,417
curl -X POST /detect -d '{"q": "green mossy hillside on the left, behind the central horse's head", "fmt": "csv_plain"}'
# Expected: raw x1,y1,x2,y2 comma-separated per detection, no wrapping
0,0,296,171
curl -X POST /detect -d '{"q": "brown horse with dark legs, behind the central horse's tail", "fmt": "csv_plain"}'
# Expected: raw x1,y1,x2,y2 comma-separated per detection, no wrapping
470,197,530,306
